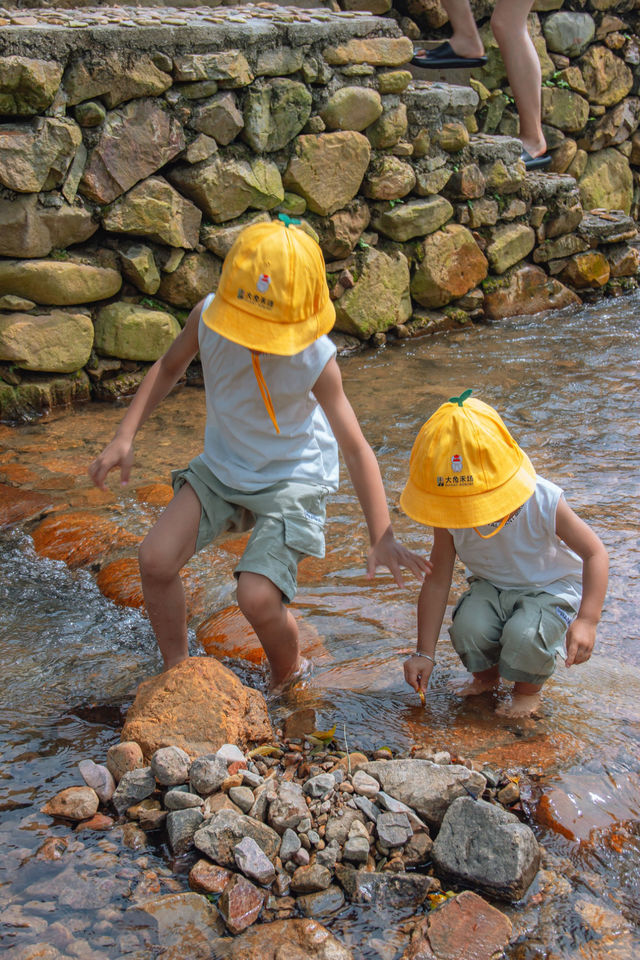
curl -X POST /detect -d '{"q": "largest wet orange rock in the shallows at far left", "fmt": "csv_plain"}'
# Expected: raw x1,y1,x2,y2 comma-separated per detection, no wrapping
33,510,142,567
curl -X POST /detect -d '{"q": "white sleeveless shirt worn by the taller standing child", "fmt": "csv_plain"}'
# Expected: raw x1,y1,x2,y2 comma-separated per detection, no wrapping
198,294,338,491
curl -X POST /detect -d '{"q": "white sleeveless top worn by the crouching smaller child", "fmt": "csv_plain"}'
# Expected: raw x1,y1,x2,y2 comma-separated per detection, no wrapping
449,477,582,610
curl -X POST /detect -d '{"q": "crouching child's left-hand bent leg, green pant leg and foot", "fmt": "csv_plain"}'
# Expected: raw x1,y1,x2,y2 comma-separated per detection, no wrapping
449,580,504,697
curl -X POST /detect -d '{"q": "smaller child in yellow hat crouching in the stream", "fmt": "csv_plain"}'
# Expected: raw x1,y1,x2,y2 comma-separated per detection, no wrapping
400,390,608,716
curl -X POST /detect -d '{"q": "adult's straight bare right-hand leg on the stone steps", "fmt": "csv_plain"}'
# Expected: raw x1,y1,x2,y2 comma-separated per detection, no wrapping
491,0,547,157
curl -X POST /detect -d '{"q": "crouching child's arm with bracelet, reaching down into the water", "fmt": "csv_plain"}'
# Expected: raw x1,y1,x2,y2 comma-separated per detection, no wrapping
404,527,456,693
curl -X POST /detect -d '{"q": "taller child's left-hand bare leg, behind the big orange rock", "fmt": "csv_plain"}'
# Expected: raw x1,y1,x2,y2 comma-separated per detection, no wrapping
138,483,201,670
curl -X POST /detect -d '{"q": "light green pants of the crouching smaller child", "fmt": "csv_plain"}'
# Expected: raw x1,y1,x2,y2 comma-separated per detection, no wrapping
449,579,576,684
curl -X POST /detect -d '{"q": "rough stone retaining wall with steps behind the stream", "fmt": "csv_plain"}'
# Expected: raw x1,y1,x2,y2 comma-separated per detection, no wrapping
0,0,640,419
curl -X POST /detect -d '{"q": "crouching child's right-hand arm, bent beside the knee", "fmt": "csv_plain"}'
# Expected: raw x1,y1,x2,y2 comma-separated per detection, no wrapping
556,497,609,667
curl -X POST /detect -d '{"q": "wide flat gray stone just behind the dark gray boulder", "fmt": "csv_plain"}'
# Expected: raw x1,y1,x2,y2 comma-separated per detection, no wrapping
362,760,486,827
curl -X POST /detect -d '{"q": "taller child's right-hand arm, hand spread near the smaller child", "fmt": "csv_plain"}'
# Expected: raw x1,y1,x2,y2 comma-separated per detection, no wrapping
313,357,430,587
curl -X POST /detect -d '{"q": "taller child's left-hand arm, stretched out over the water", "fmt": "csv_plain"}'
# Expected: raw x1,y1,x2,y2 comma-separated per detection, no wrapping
89,301,203,490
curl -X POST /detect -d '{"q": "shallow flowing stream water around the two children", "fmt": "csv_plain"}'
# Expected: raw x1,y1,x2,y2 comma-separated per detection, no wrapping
0,296,640,960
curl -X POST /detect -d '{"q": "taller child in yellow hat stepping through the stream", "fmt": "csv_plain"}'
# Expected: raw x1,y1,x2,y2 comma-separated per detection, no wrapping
89,218,428,688
